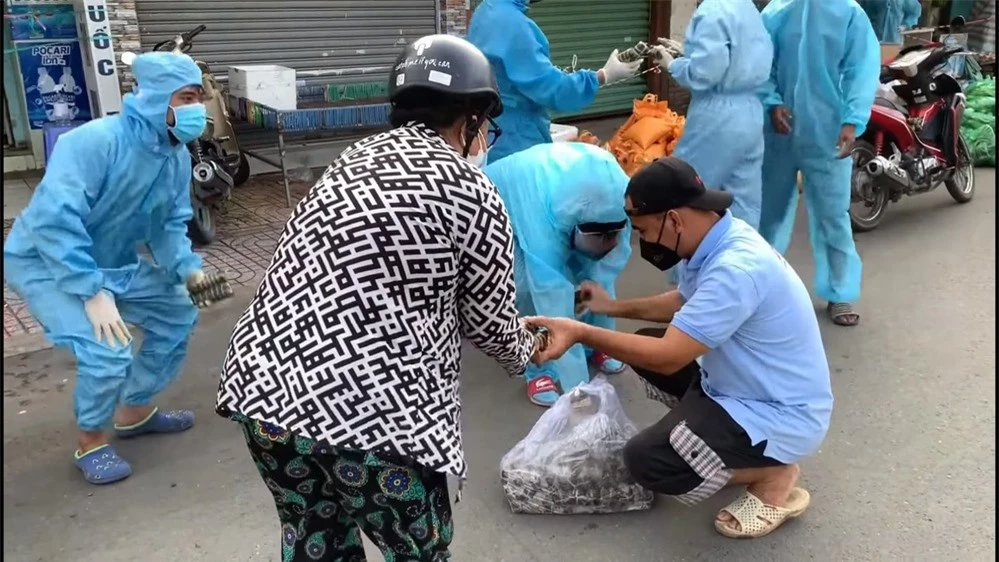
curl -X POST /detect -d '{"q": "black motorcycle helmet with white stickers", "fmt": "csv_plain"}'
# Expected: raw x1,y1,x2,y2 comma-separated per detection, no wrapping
389,35,503,156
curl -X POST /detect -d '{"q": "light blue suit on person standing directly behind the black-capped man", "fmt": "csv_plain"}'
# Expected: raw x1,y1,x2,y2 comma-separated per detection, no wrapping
669,0,773,228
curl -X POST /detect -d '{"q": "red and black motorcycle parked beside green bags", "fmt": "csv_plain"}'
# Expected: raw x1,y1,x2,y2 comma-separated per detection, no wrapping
850,17,975,232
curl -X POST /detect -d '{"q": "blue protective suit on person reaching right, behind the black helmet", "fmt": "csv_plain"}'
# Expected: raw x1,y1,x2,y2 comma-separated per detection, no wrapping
467,0,600,162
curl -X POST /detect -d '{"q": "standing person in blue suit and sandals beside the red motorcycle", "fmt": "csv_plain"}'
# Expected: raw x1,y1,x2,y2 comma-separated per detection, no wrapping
760,0,881,326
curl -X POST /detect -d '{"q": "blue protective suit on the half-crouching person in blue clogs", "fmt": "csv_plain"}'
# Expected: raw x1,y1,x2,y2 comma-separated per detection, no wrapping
3,53,201,431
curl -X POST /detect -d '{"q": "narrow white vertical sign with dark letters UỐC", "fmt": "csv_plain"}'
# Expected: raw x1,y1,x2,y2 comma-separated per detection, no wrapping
78,0,121,117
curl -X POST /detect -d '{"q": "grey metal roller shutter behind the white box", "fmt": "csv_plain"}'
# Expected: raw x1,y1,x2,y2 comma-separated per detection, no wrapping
136,0,437,84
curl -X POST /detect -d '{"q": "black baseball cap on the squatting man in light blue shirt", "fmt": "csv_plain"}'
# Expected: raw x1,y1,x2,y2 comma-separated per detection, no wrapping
624,156,732,216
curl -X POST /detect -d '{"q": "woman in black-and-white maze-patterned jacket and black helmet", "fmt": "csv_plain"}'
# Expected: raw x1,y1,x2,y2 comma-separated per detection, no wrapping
216,35,535,562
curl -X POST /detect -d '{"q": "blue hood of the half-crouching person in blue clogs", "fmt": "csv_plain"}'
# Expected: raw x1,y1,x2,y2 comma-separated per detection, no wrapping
123,53,201,154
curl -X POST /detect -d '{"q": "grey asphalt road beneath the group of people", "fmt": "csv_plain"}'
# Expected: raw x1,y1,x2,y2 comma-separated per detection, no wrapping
3,170,996,562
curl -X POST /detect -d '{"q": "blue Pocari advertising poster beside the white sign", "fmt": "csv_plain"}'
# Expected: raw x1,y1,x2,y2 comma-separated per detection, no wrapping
9,4,92,129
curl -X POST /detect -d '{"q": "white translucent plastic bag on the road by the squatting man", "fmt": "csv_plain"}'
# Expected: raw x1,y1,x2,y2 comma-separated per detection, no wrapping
500,377,653,515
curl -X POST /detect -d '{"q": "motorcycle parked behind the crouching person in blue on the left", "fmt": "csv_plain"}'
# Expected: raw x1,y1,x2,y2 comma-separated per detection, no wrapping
145,25,250,246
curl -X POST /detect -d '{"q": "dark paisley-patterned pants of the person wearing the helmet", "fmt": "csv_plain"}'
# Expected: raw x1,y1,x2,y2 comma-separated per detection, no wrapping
238,418,452,562
